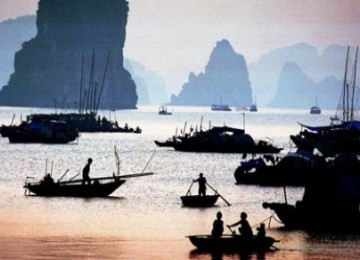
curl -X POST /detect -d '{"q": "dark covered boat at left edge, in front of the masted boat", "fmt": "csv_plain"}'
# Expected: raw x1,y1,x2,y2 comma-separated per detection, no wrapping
0,114,79,144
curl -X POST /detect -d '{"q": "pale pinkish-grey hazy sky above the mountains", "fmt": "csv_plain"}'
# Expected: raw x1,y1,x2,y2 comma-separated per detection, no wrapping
0,0,360,94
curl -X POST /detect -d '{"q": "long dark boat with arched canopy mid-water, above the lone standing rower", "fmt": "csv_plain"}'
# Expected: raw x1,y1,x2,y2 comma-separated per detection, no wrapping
173,126,282,153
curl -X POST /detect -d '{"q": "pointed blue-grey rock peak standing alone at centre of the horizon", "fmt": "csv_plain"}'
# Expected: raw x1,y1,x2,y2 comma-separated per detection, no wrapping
170,40,252,106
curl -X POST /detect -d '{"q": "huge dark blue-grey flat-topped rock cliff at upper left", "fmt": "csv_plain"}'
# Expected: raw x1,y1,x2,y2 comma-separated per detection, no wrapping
0,0,137,109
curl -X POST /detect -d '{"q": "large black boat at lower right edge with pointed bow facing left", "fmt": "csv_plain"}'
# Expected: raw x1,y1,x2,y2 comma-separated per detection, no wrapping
263,154,360,233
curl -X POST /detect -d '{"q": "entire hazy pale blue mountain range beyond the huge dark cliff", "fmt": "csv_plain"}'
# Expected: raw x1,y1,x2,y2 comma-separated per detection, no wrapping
0,16,359,109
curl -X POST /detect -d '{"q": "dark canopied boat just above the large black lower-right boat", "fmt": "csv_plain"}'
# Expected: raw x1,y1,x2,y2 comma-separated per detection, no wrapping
234,153,325,186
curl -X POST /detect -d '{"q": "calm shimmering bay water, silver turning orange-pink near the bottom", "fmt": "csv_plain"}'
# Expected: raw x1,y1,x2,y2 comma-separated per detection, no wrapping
0,106,360,259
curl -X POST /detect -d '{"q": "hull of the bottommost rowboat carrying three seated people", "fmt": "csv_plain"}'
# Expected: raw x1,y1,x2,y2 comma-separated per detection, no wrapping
188,235,279,252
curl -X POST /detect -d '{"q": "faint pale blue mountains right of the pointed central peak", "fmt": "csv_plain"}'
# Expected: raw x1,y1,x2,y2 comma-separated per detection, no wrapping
249,43,354,109
